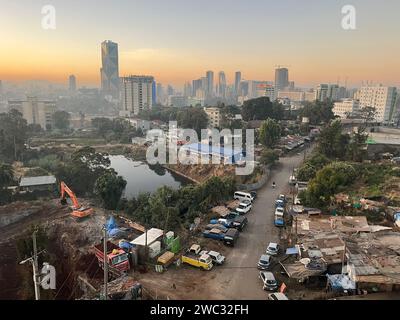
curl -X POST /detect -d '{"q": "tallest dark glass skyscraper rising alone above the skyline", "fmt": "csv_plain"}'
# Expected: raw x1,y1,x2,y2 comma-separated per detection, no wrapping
101,40,120,99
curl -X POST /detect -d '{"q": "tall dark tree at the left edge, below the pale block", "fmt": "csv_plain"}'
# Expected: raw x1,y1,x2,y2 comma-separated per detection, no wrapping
0,110,28,161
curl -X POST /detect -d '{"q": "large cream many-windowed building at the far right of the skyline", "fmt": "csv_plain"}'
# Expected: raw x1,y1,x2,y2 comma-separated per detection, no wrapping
355,86,397,123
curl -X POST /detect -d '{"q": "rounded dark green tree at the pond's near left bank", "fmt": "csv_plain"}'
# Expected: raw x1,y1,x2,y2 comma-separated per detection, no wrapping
94,170,127,210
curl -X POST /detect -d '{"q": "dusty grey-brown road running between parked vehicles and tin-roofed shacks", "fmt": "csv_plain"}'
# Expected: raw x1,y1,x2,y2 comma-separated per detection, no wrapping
211,154,304,300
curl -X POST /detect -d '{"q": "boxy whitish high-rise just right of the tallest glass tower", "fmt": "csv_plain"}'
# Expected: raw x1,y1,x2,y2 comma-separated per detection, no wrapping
122,76,154,115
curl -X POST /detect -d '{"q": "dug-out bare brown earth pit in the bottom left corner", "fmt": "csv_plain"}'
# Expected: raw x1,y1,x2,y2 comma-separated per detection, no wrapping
0,203,106,300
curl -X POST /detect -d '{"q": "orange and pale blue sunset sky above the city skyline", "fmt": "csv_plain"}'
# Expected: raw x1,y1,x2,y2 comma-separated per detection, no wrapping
0,0,400,86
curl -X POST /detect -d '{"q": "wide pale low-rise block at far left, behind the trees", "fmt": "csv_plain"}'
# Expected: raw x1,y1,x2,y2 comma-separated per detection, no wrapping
8,97,57,130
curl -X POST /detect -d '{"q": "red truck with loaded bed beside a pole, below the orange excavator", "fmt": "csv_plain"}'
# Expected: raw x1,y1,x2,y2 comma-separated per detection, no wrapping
94,241,130,272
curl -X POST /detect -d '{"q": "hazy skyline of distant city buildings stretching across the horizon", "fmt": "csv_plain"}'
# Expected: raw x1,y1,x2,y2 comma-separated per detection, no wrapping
0,40,400,129
